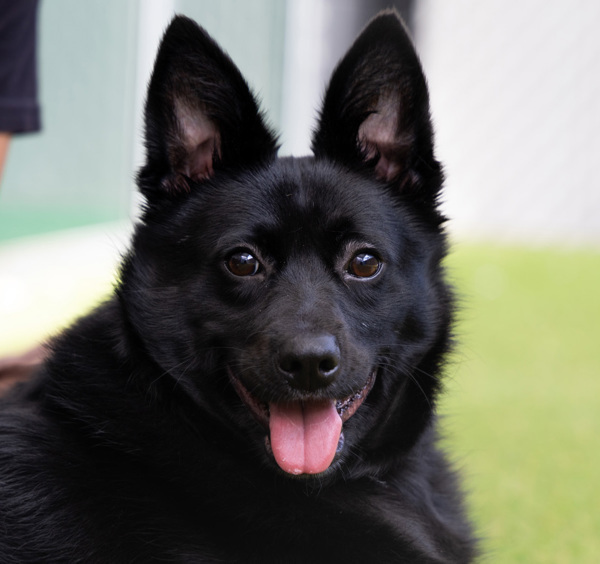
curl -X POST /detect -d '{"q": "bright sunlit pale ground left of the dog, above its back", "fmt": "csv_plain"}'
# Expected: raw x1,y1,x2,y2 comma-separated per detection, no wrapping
0,222,132,356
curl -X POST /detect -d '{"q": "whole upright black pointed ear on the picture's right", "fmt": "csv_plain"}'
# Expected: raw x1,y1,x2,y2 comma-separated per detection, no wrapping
312,10,442,207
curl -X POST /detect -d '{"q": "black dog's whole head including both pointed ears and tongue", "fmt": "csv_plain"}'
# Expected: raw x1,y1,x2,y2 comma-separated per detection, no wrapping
119,12,450,478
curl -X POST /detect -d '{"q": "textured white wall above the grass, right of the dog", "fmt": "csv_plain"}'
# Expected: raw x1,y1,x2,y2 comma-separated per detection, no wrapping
416,0,600,245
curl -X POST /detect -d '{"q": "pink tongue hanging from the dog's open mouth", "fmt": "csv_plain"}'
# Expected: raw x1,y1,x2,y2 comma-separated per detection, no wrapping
269,401,342,474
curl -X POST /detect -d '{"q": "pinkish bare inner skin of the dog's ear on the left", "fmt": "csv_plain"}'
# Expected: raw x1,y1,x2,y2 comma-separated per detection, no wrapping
175,101,221,181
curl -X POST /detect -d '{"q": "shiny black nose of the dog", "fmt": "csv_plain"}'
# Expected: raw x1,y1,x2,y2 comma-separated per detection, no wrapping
279,335,340,392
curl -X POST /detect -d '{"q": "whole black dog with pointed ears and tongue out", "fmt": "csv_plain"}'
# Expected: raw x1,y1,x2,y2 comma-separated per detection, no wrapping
0,12,474,564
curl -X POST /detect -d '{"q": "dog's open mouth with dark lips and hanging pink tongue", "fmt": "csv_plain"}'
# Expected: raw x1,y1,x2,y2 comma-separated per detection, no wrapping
229,370,376,475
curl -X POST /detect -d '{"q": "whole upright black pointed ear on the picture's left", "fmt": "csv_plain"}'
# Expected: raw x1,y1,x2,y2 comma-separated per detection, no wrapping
138,16,277,200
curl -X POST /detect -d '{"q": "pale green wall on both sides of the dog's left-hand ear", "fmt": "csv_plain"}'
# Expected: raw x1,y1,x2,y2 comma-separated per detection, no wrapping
0,0,285,240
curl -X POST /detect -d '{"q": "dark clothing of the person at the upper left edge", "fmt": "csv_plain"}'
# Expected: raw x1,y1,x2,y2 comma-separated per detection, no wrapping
0,0,40,133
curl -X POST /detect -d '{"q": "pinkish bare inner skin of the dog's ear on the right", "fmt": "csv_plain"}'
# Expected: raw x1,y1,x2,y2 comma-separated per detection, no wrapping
358,96,403,182
